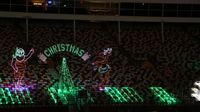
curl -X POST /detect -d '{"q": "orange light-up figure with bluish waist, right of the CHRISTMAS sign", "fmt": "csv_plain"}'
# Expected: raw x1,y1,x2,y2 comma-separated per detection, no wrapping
92,48,112,90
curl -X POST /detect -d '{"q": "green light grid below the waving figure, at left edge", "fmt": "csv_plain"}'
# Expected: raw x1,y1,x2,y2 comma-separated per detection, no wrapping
0,88,33,104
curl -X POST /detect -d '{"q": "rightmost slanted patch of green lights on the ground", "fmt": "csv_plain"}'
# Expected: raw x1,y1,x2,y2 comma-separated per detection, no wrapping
149,87,180,105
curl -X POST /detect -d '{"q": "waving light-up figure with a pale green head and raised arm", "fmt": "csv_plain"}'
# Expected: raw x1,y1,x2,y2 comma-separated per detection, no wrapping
11,47,34,85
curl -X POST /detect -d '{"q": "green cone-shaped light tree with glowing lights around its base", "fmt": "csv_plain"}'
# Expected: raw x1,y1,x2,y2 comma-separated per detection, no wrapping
48,58,79,104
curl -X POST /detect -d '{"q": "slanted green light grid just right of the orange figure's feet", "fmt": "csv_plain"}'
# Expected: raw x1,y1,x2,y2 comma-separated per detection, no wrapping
105,87,143,103
